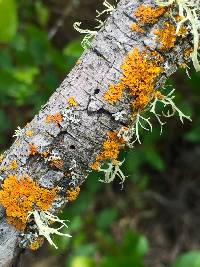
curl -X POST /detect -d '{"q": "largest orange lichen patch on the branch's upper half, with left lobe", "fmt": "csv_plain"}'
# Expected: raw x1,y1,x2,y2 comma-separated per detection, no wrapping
104,48,163,110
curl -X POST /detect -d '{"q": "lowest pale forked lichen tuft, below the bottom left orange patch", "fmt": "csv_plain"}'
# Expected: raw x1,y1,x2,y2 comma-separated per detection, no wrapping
27,210,71,249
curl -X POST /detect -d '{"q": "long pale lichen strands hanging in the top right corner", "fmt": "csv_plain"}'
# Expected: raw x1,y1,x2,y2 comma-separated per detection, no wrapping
156,0,200,71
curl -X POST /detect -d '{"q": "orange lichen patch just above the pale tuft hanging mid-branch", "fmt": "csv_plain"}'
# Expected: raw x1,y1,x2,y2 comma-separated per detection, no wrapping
91,131,124,170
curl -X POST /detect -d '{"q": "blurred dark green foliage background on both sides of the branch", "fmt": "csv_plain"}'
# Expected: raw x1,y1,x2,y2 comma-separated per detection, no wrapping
0,0,200,267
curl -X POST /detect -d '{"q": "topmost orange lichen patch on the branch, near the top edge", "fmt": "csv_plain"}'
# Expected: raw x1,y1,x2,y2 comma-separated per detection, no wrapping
135,4,167,25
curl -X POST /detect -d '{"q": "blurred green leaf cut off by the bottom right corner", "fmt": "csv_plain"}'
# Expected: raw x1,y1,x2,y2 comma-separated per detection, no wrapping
173,251,200,267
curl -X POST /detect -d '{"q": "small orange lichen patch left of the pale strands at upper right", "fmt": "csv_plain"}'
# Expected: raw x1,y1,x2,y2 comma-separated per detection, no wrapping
154,22,177,50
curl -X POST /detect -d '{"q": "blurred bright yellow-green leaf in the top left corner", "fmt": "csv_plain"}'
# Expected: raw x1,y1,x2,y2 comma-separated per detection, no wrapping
0,0,17,43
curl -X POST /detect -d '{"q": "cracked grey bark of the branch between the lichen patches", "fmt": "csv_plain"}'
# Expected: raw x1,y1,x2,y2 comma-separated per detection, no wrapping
0,0,192,266
